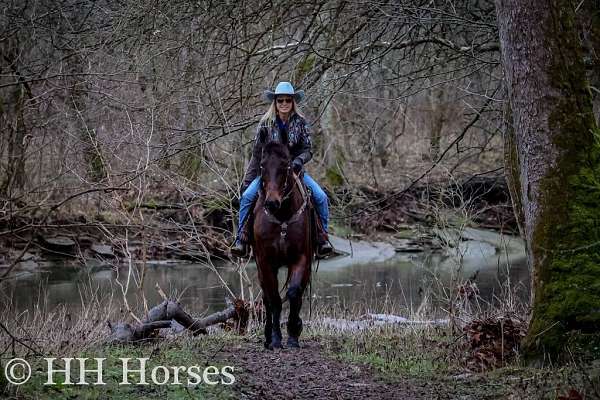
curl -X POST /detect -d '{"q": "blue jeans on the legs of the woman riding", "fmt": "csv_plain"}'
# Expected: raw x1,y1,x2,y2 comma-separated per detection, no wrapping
236,172,329,241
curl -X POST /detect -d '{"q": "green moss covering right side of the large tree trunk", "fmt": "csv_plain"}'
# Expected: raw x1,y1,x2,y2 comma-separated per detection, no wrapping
523,6,600,359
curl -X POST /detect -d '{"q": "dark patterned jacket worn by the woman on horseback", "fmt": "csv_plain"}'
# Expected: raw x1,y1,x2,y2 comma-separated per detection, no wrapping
242,113,312,193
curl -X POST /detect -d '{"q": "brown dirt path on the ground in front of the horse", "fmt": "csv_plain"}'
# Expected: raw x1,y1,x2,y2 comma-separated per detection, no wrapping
217,341,438,400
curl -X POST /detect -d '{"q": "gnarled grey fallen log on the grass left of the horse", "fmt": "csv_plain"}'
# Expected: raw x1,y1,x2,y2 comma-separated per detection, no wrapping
108,299,249,343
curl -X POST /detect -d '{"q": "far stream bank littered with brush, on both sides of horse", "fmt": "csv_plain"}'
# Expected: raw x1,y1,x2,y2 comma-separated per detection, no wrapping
0,178,518,275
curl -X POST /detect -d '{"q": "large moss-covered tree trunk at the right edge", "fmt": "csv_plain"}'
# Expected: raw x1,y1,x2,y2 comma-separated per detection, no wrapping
496,0,600,360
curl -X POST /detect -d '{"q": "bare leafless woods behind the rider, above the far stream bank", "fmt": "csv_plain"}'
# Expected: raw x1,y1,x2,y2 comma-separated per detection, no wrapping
0,0,556,246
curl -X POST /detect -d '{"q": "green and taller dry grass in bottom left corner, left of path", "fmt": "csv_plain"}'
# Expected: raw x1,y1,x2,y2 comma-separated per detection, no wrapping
0,291,241,400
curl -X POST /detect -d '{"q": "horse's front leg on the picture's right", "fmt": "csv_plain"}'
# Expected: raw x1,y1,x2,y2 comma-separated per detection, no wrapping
287,256,310,347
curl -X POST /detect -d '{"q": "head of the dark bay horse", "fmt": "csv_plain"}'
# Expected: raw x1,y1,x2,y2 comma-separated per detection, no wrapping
260,142,294,211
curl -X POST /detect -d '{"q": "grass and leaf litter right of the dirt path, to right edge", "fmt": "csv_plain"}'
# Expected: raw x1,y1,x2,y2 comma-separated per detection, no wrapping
310,327,600,400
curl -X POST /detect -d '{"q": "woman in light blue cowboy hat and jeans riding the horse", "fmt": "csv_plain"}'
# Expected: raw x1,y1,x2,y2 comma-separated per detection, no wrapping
231,82,333,257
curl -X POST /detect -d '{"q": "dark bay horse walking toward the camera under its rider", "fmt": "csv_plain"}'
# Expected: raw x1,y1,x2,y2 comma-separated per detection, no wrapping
252,142,314,349
